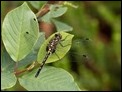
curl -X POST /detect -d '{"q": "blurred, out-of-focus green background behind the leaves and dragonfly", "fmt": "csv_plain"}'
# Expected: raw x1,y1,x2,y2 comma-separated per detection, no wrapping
1,1,121,91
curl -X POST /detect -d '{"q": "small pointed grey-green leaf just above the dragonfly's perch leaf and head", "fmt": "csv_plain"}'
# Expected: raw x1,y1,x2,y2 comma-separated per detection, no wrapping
52,19,73,31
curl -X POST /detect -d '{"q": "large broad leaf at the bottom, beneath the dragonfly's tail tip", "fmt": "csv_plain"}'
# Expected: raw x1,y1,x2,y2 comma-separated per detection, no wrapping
19,67,80,91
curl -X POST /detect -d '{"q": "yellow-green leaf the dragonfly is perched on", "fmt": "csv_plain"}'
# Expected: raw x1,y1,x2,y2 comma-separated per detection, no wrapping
37,31,74,63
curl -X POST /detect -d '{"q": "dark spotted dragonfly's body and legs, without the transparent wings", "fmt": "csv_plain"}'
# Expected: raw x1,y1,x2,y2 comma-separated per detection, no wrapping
35,33,70,77
